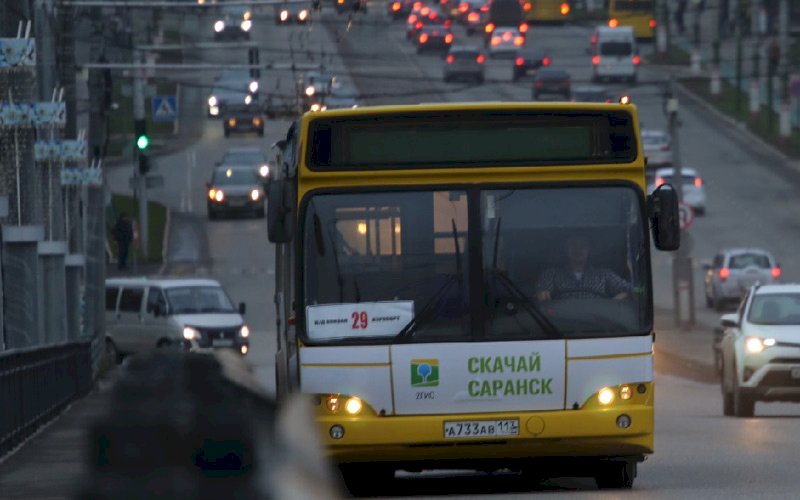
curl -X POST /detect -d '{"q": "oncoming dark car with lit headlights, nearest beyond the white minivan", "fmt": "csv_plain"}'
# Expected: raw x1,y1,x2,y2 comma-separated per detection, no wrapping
206,165,265,219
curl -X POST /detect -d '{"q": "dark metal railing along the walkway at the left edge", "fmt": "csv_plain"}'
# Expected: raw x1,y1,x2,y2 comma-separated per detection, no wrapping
0,340,92,457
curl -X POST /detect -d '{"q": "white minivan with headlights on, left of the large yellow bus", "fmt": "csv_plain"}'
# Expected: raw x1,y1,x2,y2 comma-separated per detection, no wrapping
106,278,250,360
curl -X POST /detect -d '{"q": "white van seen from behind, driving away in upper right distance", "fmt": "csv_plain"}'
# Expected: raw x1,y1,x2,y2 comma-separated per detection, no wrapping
592,26,641,83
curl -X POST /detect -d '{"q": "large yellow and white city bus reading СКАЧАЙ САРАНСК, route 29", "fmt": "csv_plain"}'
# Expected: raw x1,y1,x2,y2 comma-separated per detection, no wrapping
268,103,679,492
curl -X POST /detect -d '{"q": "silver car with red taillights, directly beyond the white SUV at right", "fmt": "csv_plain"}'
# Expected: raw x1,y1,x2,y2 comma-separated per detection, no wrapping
703,248,781,311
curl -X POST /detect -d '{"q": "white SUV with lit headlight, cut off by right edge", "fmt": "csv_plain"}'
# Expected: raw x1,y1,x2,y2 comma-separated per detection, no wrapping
719,284,800,417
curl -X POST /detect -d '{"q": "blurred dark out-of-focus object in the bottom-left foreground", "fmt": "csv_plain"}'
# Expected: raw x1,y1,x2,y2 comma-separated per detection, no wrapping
76,352,339,500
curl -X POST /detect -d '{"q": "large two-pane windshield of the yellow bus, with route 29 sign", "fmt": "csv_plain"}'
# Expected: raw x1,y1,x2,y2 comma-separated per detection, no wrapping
302,185,652,343
